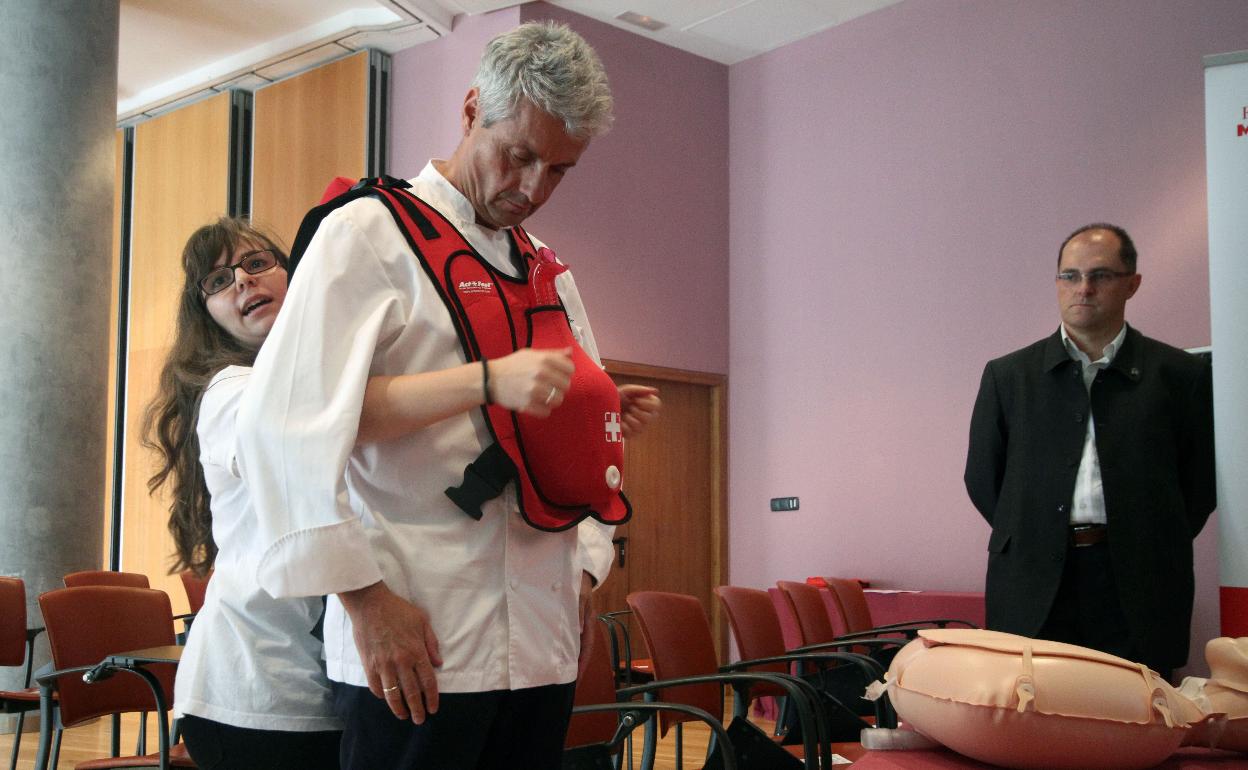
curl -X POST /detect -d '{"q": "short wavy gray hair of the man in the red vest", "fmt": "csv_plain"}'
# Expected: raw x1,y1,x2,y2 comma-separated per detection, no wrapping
472,21,613,139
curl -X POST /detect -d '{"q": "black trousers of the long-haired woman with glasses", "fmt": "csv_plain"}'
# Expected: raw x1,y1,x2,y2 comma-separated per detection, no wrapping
182,715,342,770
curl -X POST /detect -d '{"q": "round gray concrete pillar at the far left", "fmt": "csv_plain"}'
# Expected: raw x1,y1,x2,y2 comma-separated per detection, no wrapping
0,0,120,708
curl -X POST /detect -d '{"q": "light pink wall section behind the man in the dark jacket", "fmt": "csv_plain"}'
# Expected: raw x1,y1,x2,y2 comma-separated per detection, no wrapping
729,0,1248,673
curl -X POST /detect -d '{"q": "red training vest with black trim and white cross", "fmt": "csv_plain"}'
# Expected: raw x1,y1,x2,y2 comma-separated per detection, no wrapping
288,177,631,532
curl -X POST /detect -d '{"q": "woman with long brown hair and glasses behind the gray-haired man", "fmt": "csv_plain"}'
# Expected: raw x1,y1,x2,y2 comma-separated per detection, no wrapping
145,218,341,770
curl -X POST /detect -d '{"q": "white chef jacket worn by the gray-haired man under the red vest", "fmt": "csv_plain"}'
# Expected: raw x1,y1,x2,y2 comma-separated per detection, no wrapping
238,162,613,693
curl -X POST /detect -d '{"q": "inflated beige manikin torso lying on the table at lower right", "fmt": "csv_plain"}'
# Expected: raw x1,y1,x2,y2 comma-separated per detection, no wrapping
875,629,1228,770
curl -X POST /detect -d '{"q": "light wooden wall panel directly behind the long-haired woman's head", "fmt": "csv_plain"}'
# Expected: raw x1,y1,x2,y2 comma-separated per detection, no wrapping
121,94,231,612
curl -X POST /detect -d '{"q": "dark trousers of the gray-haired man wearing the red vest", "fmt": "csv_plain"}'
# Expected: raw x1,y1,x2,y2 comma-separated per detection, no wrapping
331,681,575,770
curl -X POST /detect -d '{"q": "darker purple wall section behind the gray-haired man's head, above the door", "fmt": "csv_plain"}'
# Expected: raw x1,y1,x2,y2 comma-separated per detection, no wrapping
391,2,729,373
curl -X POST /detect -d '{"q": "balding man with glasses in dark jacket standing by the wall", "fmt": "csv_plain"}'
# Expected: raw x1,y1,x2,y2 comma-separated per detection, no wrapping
965,225,1216,678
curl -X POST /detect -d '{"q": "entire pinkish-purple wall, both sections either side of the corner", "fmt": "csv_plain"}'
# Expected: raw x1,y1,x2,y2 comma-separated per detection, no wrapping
392,0,1248,673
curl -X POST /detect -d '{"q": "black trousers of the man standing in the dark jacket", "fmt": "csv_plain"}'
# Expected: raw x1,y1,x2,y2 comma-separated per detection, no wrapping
1037,543,1173,681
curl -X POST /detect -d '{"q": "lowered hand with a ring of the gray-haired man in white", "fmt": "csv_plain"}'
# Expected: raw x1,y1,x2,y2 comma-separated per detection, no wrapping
338,582,442,724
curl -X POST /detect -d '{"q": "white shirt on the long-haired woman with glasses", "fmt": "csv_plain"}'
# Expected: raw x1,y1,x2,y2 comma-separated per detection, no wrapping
173,367,342,731
